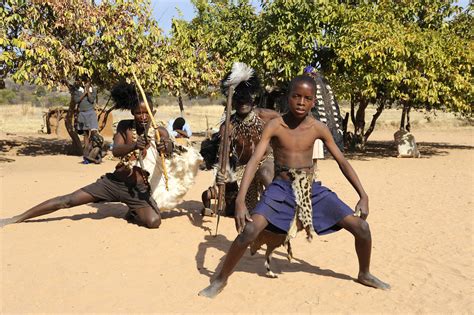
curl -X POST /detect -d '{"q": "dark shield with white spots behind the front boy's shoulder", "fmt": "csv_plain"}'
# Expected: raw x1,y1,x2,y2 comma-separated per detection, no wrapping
311,73,344,151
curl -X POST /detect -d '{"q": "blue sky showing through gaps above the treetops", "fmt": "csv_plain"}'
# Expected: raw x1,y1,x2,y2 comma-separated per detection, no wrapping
151,0,469,34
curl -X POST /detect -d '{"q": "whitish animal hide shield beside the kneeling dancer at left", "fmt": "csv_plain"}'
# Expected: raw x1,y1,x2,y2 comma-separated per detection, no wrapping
143,143,203,211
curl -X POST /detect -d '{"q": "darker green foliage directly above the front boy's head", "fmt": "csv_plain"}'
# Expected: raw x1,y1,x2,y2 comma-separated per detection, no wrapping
251,0,322,87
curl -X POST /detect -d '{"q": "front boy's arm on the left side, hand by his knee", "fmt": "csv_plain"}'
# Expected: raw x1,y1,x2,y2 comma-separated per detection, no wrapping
235,121,276,233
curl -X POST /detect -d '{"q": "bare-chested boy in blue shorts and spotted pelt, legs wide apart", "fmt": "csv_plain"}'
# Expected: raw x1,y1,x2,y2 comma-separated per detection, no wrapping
199,75,390,298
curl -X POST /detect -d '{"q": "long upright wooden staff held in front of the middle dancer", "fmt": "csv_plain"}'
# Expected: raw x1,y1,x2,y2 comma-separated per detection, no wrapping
215,85,234,236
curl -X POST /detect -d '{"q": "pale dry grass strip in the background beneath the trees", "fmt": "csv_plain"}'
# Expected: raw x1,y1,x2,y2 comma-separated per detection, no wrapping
0,103,472,133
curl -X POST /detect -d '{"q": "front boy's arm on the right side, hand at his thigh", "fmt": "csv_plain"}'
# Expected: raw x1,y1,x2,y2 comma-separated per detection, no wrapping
319,125,369,220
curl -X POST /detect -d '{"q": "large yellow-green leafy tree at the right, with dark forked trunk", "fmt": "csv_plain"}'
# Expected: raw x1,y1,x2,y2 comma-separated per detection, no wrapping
316,1,472,150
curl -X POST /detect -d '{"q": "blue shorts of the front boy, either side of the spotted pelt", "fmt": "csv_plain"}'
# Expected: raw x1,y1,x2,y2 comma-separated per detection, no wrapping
252,179,354,235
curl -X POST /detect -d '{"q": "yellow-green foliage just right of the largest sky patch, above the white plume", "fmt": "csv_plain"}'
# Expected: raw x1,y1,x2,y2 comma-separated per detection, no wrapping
164,0,255,111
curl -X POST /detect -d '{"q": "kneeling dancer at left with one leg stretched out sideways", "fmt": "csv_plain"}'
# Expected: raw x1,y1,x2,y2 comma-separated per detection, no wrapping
0,83,172,228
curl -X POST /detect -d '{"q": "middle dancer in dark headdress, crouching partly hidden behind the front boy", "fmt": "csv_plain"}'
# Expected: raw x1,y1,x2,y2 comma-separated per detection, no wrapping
201,63,280,216
